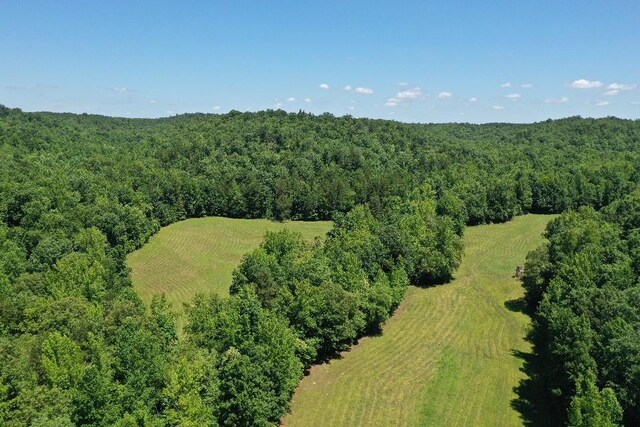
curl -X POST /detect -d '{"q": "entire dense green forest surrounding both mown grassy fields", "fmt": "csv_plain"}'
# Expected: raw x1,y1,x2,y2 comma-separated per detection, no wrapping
0,106,640,427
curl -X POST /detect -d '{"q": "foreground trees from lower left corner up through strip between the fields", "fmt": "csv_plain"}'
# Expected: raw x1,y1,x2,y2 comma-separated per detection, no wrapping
0,186,462,426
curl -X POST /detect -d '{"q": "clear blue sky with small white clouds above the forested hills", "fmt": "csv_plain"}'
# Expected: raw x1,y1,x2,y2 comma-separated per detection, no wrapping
0,0,640,123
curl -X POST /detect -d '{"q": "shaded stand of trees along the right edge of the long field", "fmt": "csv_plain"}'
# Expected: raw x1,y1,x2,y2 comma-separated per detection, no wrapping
524,191,640,426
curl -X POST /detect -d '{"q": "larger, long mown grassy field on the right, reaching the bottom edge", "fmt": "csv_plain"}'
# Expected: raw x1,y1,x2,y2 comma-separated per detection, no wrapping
283,215,551,427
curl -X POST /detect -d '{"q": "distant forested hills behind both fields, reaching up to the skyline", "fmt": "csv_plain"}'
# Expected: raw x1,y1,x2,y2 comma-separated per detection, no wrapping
0,108,640,236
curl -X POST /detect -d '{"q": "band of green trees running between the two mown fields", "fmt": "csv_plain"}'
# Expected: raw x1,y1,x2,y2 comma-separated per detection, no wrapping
183,191,462,426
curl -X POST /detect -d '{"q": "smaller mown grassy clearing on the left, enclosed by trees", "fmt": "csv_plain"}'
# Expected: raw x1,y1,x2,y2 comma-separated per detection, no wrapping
127,217,331,310
